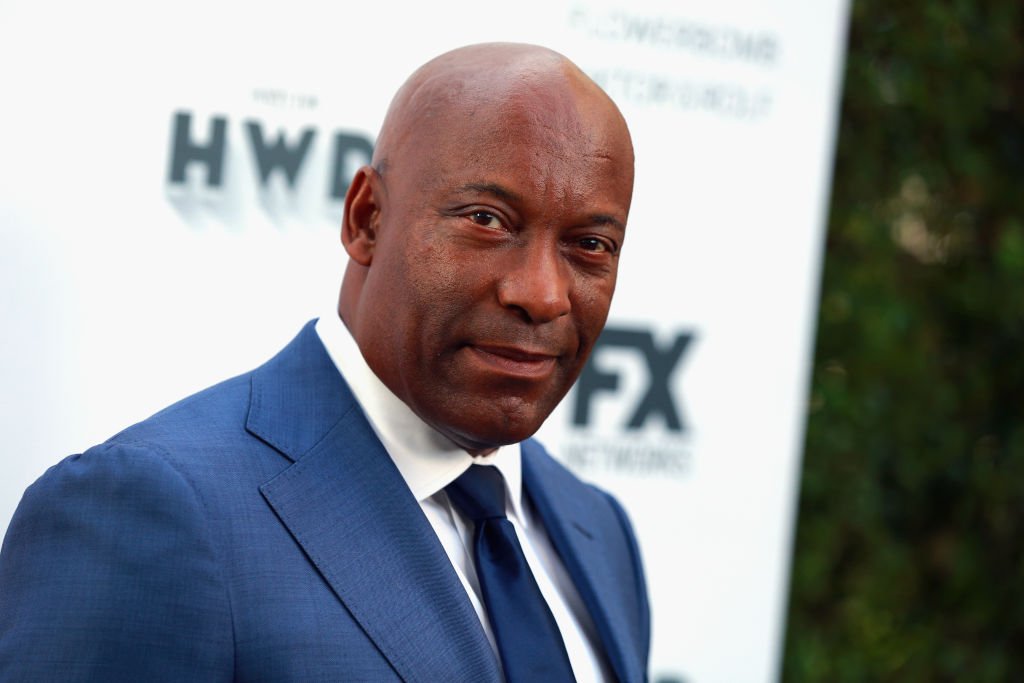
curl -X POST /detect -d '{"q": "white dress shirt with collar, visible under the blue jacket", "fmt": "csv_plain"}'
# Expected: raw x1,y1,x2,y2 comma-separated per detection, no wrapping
316,311,611,683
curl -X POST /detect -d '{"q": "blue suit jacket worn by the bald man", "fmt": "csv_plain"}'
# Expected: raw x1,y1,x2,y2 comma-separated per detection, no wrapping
0,324,649,683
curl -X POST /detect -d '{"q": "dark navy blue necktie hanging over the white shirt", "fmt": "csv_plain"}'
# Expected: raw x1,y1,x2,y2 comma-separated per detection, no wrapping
445,465,575,683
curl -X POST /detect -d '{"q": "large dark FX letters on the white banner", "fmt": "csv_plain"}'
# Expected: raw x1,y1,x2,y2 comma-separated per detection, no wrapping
572,328,693,432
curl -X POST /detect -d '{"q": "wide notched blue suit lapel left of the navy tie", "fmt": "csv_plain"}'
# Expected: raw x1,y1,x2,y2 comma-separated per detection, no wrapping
248,326,500,681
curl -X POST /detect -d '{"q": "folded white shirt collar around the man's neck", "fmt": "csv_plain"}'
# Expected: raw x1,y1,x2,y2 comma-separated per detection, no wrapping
316,311,527,525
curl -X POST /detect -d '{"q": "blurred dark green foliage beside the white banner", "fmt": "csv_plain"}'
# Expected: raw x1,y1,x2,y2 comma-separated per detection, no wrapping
783,0,1024,682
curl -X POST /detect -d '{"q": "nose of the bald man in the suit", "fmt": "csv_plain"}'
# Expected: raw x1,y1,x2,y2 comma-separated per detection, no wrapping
498,242,572,324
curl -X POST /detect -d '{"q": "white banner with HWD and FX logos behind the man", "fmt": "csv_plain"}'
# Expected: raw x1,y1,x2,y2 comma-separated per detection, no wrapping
0,0,847,683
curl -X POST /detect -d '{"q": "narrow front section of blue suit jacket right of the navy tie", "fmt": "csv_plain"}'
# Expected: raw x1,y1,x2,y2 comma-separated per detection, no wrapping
522,440,645,683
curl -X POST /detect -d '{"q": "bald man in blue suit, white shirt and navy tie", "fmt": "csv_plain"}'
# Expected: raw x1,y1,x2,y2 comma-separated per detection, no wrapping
0,44,649,682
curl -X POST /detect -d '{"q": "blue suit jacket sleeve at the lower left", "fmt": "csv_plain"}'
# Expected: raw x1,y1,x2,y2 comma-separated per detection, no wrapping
0,444,233,683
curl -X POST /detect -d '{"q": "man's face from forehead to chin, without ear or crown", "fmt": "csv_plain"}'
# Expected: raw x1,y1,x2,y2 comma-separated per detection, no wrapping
357,83,633,452
